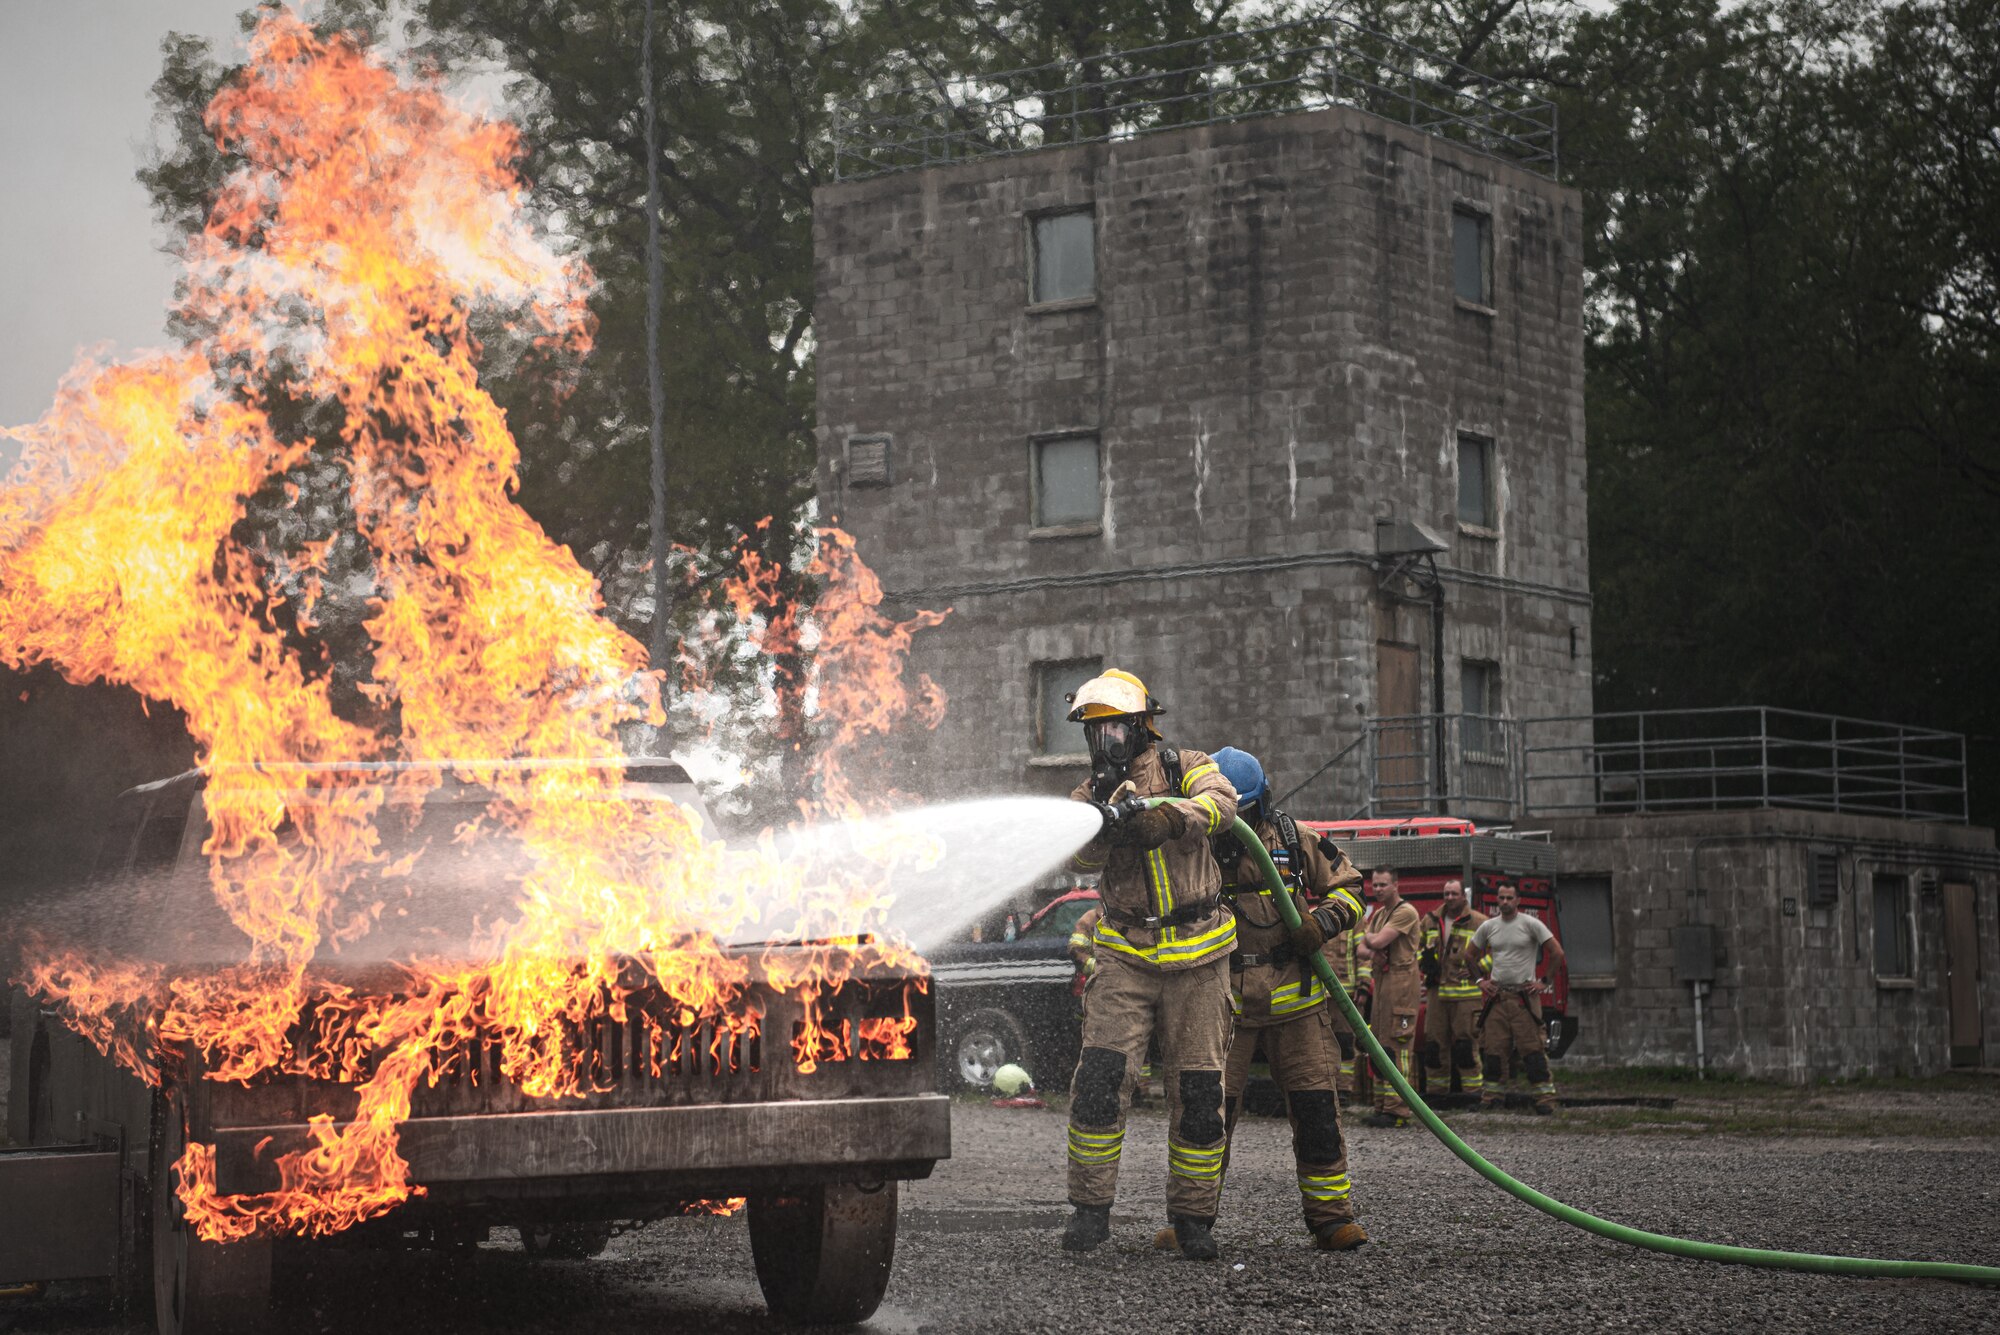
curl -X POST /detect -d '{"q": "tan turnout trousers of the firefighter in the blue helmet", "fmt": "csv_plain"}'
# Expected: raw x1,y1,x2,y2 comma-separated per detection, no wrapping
1222,1005,1354,1229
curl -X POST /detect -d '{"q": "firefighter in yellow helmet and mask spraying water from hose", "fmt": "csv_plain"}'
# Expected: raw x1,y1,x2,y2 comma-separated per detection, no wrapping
1062,671,1236,1261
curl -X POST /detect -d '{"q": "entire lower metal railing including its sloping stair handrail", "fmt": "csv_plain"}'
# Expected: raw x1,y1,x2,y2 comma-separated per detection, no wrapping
1278,705,1968,823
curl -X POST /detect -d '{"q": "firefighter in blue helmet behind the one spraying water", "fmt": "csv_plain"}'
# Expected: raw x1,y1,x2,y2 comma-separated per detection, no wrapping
1216,747,1368,1251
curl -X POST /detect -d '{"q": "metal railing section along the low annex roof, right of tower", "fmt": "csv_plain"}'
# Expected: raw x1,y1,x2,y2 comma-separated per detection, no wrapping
1520,705,1968,821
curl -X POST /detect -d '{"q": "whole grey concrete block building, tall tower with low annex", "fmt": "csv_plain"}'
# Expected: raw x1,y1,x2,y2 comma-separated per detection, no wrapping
814,32,2000,1079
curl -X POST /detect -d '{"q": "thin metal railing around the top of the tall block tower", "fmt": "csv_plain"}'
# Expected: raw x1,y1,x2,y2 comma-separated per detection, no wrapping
834,16,1558,180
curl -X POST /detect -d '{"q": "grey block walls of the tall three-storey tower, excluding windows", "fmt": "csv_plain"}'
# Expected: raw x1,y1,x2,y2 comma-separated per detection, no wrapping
814,108,1590,815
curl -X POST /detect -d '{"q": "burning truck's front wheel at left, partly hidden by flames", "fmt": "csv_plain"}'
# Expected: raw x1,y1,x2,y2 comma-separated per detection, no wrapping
148,1081,272,1335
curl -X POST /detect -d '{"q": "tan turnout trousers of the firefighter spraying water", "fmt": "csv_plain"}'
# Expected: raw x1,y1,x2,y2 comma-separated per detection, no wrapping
1070,951,1230,1219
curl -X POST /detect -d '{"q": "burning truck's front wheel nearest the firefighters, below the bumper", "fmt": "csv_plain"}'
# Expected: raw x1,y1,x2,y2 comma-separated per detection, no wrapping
750,1181,896,1325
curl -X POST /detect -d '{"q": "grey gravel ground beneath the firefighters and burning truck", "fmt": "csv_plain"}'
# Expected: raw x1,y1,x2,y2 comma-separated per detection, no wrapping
0,1081,2000,1335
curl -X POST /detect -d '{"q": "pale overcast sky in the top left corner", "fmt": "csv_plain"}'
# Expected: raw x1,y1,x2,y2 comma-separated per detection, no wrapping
0,0,262,426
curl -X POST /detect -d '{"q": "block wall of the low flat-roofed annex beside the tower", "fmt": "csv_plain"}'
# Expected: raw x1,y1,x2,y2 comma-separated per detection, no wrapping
1548,811,2000,1081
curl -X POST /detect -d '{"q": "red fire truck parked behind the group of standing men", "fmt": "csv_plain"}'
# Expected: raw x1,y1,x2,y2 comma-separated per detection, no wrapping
1300,815,1576,1093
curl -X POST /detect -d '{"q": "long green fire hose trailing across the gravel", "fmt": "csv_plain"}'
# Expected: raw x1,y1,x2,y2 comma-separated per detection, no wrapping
1200,819,2000,1285
